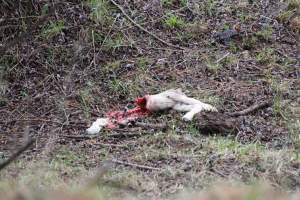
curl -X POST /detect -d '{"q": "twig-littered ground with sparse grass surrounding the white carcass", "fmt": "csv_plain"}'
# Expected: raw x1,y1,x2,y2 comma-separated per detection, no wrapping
0,0,300,199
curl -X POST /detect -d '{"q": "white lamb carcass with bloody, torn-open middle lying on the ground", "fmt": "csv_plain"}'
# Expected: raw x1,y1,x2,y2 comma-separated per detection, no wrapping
86,89,217,134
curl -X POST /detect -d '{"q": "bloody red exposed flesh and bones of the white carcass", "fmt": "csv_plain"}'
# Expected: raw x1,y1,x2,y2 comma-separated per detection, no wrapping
106,98,149,129
